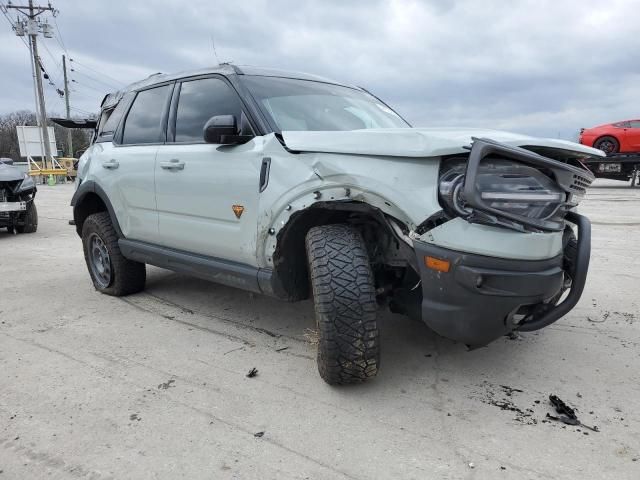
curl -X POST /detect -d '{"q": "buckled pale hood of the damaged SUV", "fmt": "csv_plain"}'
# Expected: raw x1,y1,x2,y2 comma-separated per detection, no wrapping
282,128,604,157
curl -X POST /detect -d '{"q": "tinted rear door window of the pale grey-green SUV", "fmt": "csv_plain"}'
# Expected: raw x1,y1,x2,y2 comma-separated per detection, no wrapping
121,85,171,144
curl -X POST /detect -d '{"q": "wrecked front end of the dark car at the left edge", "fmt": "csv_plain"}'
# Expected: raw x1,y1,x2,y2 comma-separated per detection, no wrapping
0,163,37,232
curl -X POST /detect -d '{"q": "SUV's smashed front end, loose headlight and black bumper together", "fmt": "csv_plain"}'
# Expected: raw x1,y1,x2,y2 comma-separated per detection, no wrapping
404,138,594,347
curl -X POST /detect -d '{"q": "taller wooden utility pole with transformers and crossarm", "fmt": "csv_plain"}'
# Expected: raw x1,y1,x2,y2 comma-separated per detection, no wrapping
6,0,57,169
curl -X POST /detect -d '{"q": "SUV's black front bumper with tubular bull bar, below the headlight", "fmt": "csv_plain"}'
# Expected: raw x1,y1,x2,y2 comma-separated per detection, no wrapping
414,212,591,346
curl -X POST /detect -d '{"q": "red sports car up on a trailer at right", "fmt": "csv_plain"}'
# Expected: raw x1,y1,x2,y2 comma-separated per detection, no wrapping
580,120,640,155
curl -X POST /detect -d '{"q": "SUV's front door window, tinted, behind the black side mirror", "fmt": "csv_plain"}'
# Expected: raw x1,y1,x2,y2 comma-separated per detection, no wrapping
175,78,242,143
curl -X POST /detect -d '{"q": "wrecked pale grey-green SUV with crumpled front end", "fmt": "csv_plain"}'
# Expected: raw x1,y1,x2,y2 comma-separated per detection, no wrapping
67,65,602,384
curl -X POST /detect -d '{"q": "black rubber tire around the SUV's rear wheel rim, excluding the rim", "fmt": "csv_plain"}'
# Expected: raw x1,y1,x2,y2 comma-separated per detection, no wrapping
82,212,147,297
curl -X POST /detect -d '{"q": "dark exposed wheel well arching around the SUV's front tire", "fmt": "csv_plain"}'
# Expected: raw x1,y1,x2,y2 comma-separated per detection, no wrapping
273,202,410,302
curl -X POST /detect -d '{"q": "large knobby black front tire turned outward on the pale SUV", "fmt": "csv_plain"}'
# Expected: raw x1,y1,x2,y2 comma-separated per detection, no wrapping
306,225,380,385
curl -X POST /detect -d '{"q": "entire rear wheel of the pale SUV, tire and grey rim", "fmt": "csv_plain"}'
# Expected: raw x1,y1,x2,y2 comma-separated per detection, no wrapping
82,212,147,297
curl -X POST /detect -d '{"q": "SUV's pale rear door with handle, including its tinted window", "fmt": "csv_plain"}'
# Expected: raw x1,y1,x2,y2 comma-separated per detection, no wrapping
105,84,173,243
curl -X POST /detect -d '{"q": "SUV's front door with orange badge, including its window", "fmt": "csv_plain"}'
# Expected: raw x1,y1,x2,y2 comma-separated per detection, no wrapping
155,76,262,265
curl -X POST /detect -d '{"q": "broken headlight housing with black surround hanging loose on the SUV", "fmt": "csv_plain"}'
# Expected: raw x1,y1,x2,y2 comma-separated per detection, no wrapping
439,139,594,231
